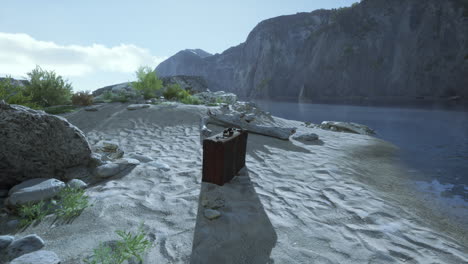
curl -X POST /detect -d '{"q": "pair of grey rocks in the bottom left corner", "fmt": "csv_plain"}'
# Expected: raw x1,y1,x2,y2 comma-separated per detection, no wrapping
0,234,60,264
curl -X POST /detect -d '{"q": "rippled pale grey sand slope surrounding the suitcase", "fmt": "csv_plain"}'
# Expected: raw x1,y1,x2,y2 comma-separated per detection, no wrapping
1,104,468,263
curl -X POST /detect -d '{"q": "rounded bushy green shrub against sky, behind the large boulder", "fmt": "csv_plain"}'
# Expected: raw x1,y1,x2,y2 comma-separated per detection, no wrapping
25,66,72,107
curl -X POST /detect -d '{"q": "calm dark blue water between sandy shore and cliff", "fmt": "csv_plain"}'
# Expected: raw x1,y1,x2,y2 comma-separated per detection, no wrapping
255,101,468,203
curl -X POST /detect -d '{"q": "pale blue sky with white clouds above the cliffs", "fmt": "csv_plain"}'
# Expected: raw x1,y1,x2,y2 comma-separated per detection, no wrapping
0,0,357,91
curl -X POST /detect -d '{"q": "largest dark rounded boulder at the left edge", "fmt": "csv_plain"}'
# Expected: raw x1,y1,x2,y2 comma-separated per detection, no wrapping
0,101,91,189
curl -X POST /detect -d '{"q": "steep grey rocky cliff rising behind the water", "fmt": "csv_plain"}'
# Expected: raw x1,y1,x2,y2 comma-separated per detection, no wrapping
156,0,468,100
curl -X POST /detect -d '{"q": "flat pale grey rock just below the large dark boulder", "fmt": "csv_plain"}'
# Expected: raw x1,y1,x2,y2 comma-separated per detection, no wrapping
8,179,65,205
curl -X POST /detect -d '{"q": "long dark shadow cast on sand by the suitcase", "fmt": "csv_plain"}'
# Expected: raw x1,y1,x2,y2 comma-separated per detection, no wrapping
190,168,277,264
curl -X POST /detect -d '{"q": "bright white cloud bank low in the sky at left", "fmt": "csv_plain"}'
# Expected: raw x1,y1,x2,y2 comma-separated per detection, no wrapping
0,32,165,79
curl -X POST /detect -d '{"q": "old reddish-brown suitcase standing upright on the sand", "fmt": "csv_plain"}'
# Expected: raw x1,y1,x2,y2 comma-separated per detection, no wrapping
202,128,248,186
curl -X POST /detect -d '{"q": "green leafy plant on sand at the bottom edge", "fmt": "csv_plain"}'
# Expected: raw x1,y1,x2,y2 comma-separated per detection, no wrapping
84,225,152,264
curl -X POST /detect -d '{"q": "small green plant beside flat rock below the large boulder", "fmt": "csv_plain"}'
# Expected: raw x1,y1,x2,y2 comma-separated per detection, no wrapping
55,187,89,219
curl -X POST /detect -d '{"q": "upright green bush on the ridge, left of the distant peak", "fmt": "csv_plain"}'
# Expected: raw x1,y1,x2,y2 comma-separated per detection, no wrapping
132,66,162,99
